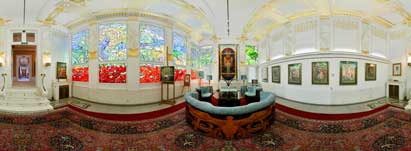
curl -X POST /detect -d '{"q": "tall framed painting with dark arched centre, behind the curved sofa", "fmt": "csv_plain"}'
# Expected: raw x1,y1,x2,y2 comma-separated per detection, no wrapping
218,44,238,80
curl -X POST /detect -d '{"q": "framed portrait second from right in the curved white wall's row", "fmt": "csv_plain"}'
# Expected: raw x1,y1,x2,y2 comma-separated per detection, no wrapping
340,61,358,85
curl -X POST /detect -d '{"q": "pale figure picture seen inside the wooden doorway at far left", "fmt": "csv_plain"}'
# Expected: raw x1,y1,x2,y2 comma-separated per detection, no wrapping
16,55,31,81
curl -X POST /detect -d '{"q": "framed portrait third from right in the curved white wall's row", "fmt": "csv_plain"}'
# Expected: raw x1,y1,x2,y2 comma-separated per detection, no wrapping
311,61,330,85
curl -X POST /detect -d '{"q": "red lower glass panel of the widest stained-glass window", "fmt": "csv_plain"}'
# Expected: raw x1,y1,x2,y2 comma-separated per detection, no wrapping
99,63,127,83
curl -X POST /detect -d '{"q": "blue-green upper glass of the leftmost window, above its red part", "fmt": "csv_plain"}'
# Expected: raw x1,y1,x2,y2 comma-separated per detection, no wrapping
71,30,89,65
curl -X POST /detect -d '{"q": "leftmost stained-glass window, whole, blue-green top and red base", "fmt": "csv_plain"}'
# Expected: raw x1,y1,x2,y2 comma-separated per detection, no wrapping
71,30,89,82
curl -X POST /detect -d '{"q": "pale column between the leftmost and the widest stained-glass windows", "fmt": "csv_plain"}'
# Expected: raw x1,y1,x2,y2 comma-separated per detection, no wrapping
88,20,99,89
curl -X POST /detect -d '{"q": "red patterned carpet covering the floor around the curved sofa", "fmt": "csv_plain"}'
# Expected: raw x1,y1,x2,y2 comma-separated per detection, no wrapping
0,102,411,151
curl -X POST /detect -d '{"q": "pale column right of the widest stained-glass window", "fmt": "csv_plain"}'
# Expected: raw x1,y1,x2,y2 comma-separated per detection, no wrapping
127,16,140,90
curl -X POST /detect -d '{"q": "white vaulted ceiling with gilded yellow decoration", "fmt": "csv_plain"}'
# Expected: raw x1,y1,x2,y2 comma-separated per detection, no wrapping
0,0,411,40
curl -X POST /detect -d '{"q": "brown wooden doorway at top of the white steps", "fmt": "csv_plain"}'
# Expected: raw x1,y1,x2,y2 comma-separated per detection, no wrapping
12,45,36,87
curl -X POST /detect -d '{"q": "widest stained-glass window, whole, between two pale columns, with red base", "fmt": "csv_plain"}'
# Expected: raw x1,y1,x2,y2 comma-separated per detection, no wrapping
98,23,127,83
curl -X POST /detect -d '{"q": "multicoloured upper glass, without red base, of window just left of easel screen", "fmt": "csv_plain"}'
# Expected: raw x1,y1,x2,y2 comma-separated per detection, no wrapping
140,24,165,63
